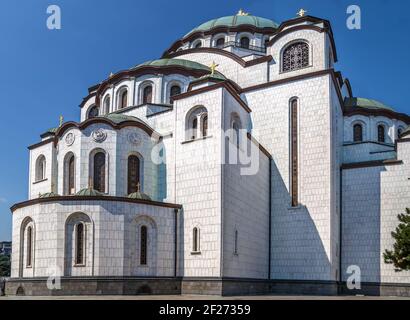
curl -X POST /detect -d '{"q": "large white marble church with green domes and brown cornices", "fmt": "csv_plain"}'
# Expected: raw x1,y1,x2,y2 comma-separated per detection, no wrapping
8,16,410,292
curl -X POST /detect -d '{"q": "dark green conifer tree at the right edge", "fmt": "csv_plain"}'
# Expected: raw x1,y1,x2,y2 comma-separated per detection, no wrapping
383,208,410,272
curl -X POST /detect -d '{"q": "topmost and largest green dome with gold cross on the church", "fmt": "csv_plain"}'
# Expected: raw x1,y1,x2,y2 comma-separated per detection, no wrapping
185,15,279,37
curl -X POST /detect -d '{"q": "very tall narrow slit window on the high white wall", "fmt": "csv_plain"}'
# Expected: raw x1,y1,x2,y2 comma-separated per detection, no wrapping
290,99,299,207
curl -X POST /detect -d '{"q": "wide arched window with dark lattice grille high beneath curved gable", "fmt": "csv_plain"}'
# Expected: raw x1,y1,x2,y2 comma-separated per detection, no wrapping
282,42,309,72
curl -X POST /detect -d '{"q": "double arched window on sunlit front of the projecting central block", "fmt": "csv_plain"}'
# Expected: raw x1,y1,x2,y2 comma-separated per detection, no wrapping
185,106,208,140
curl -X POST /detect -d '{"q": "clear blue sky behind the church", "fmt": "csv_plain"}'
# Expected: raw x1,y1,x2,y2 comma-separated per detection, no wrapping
0,0,410,241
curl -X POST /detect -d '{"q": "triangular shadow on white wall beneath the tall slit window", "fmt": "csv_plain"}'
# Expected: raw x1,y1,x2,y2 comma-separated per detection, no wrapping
271,160,336,281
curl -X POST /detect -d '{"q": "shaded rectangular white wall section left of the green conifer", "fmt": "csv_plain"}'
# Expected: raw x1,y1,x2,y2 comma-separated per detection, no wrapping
342,167,382,295
